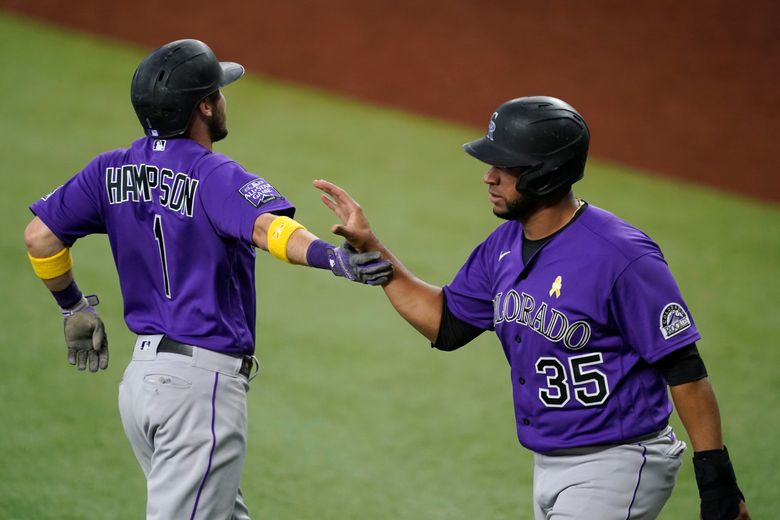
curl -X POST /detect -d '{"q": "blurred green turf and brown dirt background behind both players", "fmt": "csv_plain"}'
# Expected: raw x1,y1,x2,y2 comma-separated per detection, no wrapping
0,0,780,520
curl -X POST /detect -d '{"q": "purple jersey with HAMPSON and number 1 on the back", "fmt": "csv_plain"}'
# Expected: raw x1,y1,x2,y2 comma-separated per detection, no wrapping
30,138,295,354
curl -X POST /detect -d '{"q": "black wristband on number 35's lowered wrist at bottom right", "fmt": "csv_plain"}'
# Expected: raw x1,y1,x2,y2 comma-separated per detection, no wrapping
693,446,745,520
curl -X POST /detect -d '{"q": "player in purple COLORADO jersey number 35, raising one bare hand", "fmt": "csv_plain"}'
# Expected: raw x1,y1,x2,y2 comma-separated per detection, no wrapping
315,97,749,520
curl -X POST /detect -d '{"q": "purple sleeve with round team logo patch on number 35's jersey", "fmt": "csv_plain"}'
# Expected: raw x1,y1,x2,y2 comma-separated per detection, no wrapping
609,252,701,363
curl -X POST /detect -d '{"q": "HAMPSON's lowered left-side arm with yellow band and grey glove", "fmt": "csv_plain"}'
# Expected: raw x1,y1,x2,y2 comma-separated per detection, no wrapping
24,217,108,372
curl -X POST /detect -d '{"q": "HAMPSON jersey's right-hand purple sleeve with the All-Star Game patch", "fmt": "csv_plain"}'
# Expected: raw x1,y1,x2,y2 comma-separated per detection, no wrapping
201,161,295,245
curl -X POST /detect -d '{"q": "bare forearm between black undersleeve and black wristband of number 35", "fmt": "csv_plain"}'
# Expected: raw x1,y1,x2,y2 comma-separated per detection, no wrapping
670,377,723,452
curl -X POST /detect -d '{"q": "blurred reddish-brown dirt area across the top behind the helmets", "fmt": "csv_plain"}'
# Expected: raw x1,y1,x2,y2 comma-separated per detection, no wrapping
0,0,780,202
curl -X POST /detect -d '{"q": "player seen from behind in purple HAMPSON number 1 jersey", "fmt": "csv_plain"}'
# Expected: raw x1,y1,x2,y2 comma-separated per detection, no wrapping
25,40,392,520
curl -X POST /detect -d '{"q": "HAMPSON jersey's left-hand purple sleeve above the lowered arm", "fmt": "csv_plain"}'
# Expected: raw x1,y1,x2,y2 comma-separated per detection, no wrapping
30,156,106,247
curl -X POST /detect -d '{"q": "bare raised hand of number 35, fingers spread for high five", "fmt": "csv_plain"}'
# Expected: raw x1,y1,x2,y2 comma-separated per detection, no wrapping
312,179,379,251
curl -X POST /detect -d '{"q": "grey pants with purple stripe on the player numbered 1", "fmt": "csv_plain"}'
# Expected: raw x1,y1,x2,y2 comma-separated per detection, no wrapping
119,335,249,520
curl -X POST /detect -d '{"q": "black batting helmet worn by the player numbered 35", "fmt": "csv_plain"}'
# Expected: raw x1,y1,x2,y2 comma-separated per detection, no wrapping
463,96,590,197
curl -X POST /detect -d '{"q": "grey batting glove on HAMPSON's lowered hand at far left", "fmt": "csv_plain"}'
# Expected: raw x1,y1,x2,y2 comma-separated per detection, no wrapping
62,294,108,372
